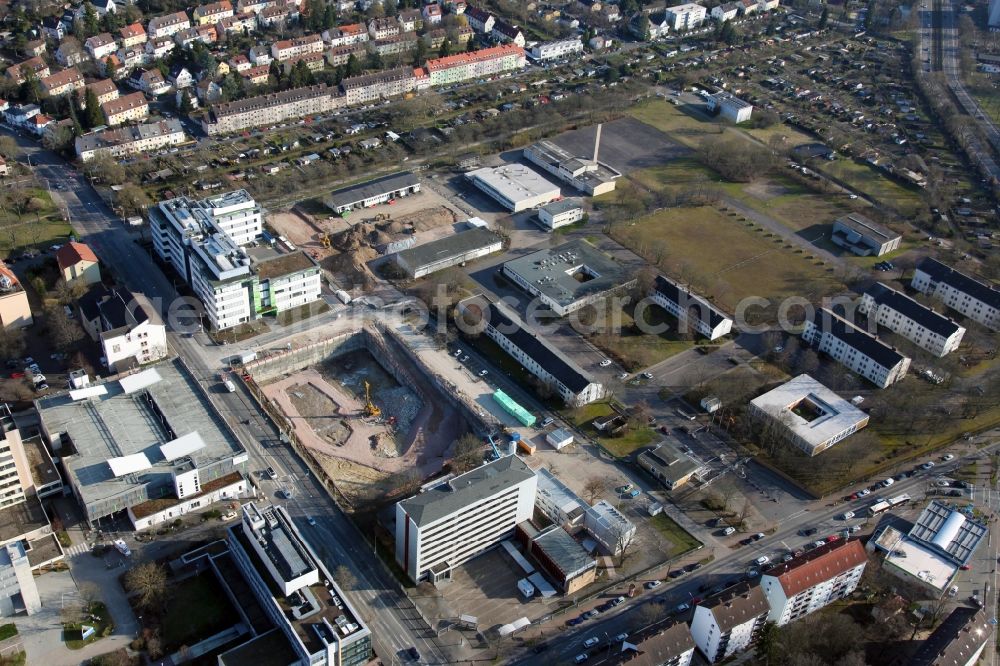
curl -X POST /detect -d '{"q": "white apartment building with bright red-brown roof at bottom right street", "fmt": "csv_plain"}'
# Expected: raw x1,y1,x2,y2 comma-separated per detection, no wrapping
760,539,868,627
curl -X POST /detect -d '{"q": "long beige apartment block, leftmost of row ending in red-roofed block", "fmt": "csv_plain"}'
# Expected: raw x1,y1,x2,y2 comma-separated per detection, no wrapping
202,84,342,135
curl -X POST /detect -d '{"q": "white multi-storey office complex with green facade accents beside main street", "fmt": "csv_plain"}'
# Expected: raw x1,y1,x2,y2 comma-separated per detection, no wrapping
149,190,321,330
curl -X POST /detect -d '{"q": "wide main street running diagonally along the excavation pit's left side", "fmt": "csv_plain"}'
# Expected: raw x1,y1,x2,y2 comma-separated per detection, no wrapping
6,136,455,664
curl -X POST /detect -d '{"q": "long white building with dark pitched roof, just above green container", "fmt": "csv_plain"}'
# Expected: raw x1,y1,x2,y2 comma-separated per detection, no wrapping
459,296,606,407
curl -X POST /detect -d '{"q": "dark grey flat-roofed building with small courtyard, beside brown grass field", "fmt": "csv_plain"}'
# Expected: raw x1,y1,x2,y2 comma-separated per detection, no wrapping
503,239,635,317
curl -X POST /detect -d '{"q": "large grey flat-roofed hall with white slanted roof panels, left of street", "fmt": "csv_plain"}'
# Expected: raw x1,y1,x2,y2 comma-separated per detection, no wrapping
35,361,247,524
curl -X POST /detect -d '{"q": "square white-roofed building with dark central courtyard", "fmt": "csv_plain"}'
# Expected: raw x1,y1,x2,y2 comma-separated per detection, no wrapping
750,375,868,456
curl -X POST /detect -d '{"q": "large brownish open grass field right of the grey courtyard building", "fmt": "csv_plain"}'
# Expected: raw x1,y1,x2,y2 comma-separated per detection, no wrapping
612,206,845,312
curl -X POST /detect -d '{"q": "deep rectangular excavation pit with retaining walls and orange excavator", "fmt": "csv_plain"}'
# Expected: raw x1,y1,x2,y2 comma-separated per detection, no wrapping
244,325,493,508
